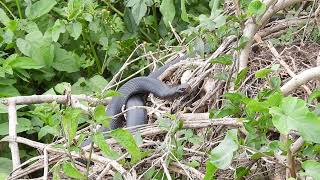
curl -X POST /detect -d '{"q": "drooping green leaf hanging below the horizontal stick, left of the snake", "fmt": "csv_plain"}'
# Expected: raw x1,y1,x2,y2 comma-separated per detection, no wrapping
61,108,82,145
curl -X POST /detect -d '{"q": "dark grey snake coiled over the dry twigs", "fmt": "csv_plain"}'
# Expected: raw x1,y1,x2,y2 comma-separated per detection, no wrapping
82,55,190,147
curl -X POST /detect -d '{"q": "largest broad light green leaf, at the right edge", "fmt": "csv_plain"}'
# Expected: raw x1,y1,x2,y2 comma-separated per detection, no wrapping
269,97,320,143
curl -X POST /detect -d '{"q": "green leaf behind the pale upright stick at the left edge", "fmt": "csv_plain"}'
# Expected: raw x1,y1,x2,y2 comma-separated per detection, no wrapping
0,118,32,136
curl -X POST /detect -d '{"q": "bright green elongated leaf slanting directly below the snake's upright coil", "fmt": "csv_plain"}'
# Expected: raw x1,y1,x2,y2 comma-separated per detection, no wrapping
111,129,142,163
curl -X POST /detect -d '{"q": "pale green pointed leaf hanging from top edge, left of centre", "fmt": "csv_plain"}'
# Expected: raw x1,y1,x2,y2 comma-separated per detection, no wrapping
126,0,147,24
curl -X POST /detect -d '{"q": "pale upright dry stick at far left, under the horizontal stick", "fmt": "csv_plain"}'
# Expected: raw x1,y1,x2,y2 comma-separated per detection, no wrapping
8,98,20,172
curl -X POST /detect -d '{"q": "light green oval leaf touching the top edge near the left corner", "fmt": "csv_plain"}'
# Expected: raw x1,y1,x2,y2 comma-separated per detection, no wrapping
26,0,57,20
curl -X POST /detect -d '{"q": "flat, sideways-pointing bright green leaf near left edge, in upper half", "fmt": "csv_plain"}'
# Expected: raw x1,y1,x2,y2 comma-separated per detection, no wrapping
9,57,44,69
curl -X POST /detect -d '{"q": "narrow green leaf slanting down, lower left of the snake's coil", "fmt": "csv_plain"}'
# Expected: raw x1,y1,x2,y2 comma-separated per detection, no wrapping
93,132,120,160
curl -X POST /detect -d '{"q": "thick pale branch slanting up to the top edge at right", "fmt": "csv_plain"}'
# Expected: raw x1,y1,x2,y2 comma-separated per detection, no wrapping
238,0,303,72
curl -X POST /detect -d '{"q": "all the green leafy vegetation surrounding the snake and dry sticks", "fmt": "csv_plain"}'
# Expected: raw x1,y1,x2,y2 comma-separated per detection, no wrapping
0,0,320,180
